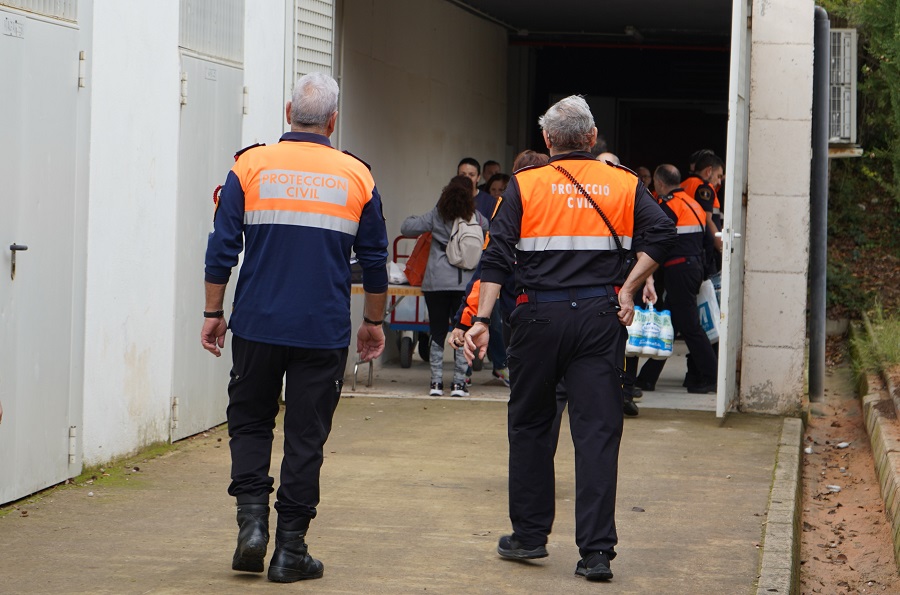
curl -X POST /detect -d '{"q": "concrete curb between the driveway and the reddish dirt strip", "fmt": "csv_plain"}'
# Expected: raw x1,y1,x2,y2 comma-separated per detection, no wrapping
756,417,800,595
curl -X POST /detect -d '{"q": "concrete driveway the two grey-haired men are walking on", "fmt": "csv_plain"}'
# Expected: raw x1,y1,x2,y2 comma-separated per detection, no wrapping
0,388,782,595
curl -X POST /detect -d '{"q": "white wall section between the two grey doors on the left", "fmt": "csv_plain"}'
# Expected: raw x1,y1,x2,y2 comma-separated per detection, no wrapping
83,0,182,464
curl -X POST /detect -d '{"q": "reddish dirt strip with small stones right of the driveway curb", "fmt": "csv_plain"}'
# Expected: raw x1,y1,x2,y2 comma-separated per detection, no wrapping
800,366,900,595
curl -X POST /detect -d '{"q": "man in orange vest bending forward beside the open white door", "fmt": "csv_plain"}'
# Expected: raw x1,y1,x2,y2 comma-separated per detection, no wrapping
635,164,717,393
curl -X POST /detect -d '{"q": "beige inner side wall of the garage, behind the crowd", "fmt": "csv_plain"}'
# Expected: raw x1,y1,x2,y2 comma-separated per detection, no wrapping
332,0,512,373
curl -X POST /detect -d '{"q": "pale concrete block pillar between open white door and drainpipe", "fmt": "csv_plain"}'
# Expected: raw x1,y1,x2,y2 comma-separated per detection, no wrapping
741,0,814,415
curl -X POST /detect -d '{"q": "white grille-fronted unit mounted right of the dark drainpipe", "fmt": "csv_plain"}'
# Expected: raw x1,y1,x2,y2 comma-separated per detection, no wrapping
828,29,856,145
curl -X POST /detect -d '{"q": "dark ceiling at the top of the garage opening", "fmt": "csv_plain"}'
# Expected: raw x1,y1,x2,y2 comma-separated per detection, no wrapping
448,0,731,45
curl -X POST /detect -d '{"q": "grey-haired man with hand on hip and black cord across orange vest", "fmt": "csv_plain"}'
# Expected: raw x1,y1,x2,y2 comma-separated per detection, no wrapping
465,96,675,580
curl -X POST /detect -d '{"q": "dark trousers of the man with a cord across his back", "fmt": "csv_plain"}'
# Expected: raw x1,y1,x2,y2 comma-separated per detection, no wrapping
508,297,626,556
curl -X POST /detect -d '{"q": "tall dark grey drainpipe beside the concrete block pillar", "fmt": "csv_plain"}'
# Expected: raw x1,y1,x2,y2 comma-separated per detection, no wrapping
809,6,831,402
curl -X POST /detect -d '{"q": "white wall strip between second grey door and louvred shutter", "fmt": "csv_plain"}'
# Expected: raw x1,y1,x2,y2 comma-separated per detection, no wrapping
241,0,293,144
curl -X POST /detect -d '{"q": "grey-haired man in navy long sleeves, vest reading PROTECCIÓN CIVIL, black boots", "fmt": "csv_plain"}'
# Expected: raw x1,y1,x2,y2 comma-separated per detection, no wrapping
200,73,388,583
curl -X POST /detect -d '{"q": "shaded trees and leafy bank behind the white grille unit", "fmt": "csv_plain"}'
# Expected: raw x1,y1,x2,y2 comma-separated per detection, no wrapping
822,0,900,317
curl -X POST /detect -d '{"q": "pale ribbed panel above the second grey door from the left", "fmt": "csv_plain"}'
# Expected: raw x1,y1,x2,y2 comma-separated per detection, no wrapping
178,0,244,64
